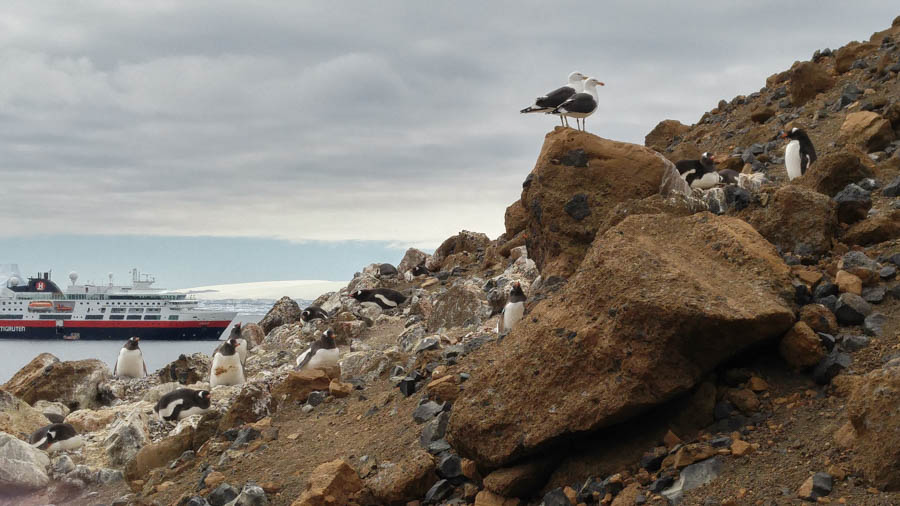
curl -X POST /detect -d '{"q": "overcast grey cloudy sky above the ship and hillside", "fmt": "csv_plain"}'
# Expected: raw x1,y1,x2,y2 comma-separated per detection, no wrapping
0,0,900,287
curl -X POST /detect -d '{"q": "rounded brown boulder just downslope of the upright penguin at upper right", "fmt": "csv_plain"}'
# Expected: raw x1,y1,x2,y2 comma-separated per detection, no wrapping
744,185,838,256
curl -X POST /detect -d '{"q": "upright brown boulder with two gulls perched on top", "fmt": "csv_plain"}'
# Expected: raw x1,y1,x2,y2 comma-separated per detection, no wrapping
521,127,672,279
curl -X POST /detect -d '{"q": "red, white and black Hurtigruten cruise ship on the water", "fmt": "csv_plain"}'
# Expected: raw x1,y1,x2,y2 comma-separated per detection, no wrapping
0,264,237,341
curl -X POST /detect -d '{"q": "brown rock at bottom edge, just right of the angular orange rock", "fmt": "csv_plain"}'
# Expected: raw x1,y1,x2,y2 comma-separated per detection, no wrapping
365,451,438,504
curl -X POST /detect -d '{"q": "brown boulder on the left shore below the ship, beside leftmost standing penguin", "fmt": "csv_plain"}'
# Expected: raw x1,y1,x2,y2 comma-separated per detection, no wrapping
3,353,110,411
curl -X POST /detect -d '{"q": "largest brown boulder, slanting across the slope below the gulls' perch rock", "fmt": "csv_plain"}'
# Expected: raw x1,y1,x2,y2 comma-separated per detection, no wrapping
448,213,794,466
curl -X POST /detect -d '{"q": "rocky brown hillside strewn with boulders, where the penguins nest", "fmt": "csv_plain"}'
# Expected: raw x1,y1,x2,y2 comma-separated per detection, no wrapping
0,13,900,506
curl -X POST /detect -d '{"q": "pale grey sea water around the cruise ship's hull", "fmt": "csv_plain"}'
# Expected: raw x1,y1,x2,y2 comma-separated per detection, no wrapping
0,299,296,384
